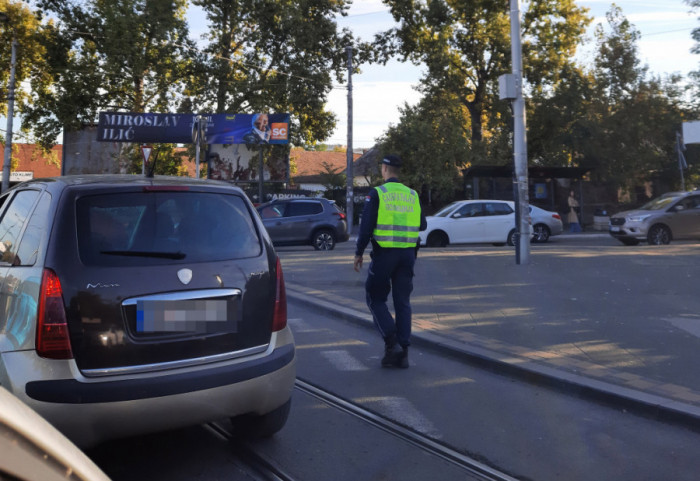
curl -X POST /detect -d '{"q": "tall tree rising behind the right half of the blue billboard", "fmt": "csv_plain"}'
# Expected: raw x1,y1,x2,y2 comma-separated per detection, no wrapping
192,0,369,145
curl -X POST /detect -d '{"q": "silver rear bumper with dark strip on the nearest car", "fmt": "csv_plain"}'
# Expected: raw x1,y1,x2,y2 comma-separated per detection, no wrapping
3,328,296,447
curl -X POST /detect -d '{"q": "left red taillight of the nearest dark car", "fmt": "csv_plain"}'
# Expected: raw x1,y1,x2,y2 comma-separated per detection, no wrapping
36,269,73,359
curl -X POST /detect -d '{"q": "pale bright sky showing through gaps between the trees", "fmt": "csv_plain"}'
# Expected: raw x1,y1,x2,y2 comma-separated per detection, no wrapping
327,0,700,148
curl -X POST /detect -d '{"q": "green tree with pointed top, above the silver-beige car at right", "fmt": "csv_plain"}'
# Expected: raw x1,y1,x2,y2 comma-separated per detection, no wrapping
528,6,687,197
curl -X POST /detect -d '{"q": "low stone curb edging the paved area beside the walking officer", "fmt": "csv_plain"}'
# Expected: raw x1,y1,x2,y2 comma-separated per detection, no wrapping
286,284,700,431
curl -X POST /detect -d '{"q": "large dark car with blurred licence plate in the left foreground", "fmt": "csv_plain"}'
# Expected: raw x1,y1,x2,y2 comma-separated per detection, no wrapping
0,175,296,446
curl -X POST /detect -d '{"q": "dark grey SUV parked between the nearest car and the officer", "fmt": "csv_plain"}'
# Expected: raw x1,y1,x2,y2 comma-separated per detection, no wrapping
258,198,348,250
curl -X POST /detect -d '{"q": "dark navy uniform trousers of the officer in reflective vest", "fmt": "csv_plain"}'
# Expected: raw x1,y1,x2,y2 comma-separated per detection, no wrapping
365,245,416,347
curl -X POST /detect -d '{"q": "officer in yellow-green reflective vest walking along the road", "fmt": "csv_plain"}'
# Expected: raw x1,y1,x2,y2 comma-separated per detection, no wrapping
354,155,427,368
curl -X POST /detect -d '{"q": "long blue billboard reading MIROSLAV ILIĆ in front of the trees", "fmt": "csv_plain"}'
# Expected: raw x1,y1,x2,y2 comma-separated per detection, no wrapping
97,112,289,145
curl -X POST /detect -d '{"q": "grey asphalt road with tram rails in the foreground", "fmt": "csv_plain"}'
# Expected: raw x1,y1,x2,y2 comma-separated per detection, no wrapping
88,302,700,481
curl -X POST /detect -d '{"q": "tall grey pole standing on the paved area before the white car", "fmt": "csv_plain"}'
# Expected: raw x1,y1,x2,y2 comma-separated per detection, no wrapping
510,0,530,264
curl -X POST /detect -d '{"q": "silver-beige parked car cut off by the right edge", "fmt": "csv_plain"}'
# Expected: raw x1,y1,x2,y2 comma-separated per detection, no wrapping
609,190,700,245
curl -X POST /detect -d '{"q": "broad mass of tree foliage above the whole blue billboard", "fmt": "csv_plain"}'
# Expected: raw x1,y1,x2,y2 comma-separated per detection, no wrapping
16,0,370,174
